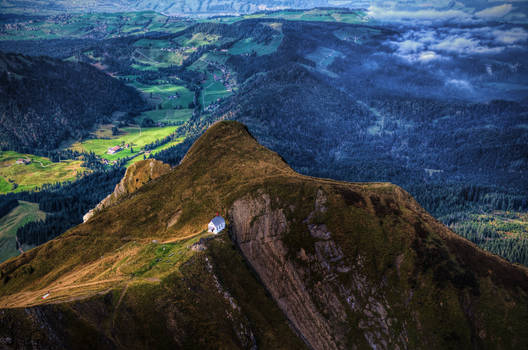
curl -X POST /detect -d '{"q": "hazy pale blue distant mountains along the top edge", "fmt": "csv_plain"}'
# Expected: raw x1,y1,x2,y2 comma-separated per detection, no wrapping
0,0,528,21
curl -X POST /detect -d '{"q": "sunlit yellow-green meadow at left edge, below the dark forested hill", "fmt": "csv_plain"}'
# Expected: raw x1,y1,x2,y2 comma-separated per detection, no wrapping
0,151,88,193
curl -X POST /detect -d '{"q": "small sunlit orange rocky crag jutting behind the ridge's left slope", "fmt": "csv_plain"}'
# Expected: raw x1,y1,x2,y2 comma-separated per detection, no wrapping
83,159,170,222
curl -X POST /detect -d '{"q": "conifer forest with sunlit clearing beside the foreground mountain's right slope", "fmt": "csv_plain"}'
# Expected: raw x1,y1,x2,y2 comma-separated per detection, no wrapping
408,184,528,266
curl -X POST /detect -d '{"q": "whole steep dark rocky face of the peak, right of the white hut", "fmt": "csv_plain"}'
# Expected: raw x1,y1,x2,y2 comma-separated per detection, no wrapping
229,184,526,350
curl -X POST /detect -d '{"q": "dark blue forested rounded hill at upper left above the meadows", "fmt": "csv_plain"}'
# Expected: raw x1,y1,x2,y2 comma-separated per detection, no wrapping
0,53,144,153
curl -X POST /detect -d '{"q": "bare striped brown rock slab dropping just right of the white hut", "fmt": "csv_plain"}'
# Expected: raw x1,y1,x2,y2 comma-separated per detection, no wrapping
230,190,406,350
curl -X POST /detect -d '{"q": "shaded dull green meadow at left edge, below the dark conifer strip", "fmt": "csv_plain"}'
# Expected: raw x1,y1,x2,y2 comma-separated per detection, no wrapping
0,201,46,262
